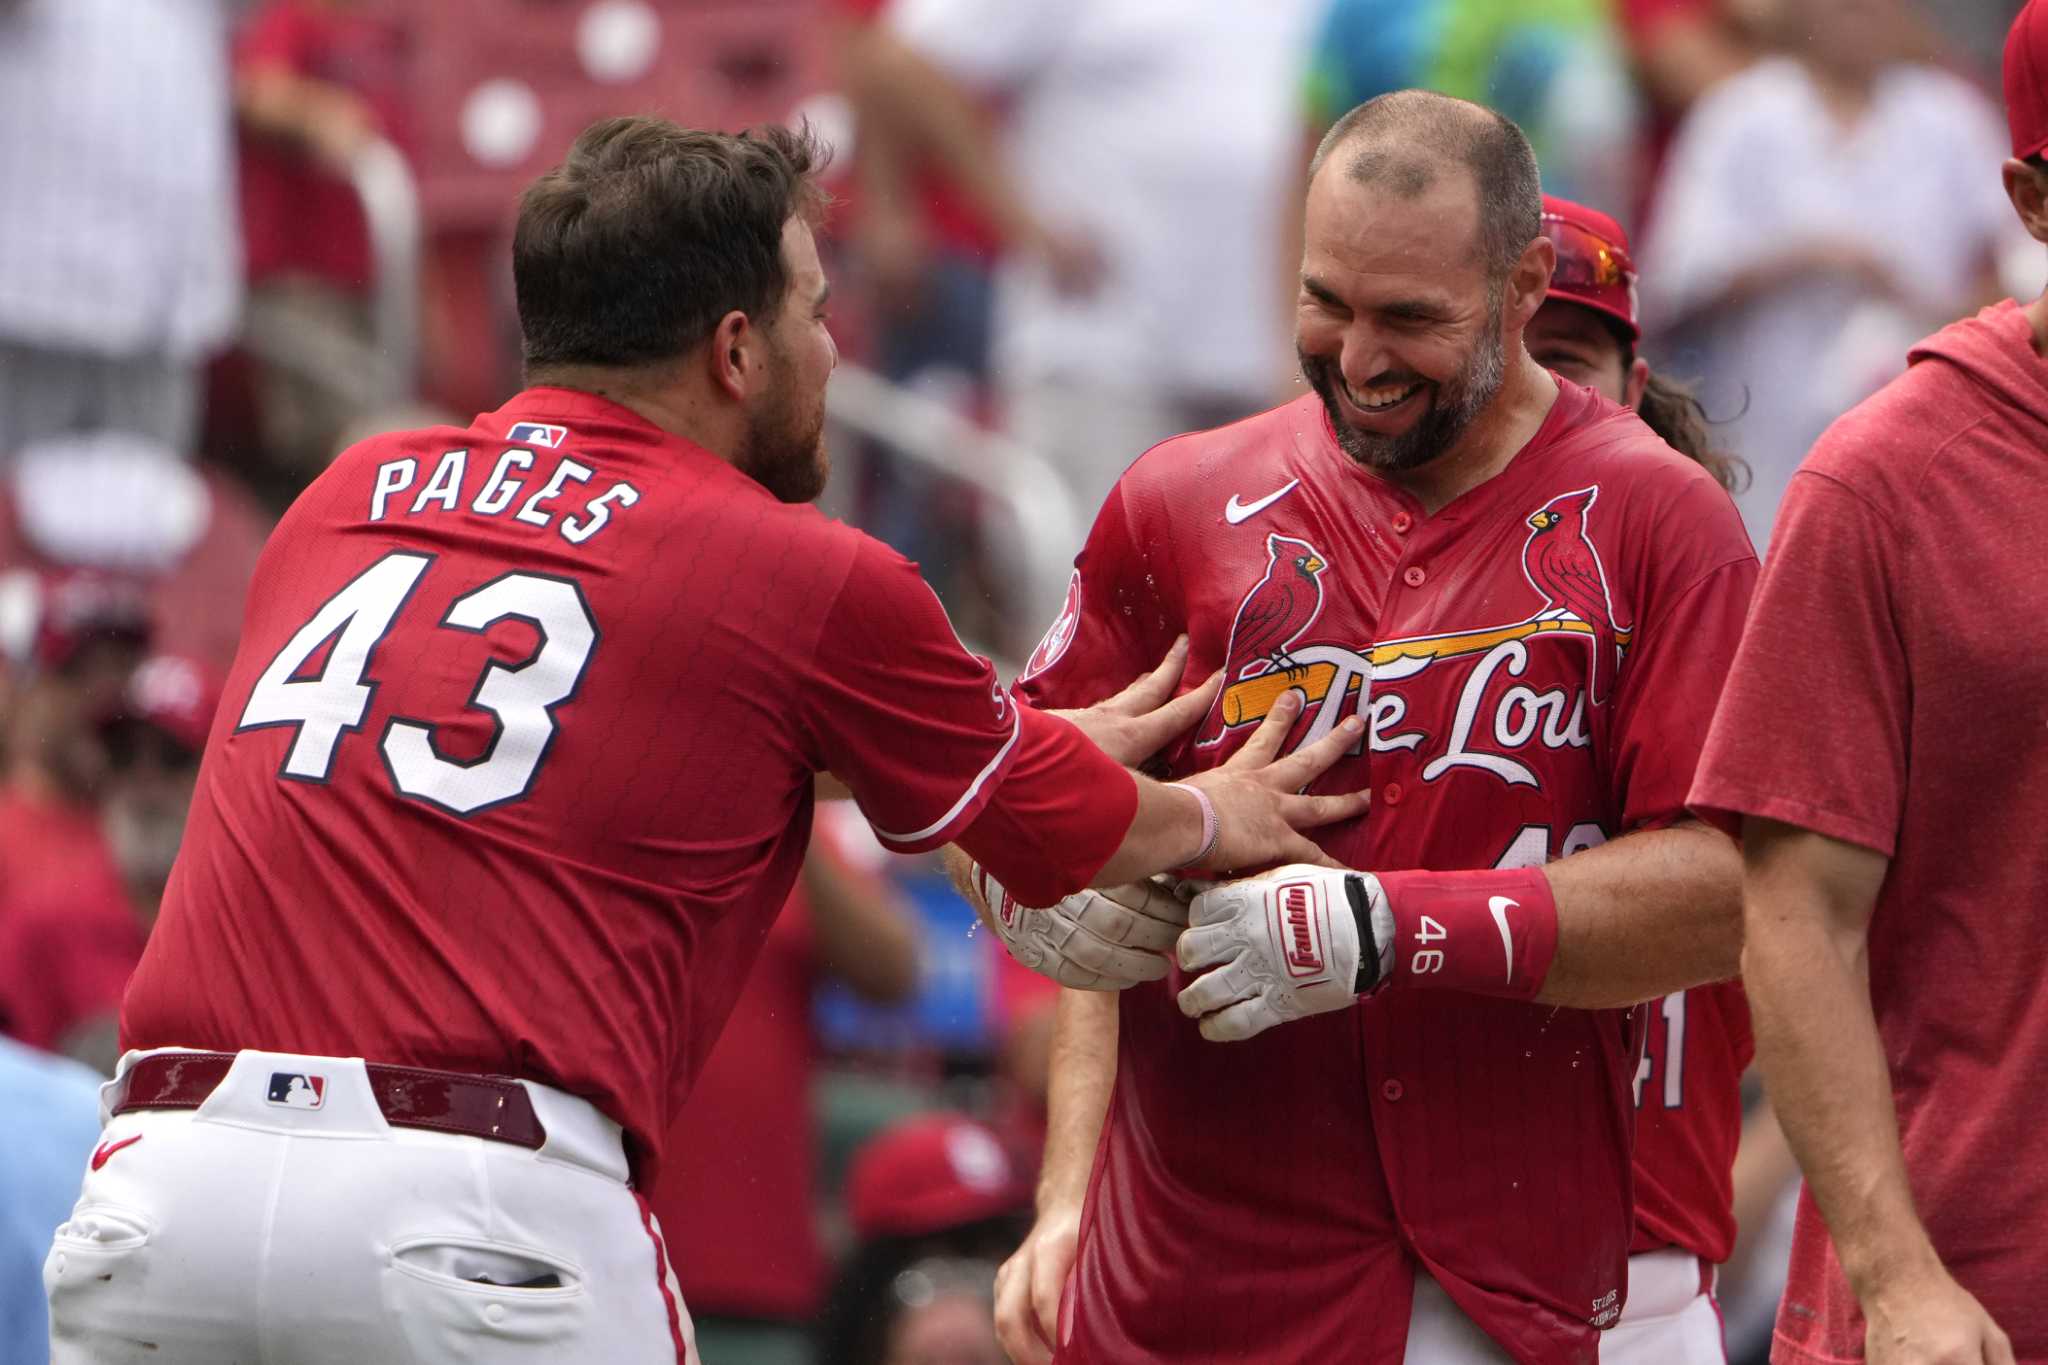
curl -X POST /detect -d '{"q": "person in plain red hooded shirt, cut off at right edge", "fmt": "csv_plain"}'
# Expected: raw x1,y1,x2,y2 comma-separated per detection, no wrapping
1692,0,2048,1365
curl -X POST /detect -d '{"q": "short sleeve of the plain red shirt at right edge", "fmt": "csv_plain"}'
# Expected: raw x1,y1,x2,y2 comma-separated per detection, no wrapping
1692,469,1909,857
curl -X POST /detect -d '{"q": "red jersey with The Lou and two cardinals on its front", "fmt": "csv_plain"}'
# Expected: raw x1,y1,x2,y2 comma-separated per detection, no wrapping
1024,383,1755,1365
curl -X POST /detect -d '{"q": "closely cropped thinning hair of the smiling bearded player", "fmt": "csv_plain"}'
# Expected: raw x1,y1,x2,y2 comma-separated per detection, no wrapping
1309,90,1542,284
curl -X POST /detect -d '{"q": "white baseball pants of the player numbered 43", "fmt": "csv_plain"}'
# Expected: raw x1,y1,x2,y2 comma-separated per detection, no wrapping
43,1052,696,1365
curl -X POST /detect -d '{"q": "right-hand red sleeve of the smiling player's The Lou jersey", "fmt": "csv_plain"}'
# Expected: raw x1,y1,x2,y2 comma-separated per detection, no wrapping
1612,483,1757,829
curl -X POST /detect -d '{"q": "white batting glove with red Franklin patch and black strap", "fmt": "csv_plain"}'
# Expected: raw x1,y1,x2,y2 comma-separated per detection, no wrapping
1178,864,1395,1042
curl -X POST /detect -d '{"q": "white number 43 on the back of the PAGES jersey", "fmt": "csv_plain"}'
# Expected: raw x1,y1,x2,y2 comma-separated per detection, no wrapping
236,551,598,814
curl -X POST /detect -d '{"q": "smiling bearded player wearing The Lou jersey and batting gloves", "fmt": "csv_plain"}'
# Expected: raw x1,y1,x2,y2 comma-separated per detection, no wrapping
950,92,1757,1365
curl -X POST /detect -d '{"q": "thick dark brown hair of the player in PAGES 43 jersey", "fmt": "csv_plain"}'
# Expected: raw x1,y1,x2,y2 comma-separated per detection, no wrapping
512,117,827,370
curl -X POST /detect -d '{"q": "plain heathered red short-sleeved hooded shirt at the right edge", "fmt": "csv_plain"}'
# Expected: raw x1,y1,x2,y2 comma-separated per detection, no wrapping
1692,303,2048,1363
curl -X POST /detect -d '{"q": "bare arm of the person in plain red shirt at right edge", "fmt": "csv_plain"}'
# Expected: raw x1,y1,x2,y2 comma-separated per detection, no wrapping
1743,819,2013,1365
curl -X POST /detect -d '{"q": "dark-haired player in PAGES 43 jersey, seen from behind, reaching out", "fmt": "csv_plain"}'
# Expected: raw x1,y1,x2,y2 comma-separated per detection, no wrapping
45,119,1364,1365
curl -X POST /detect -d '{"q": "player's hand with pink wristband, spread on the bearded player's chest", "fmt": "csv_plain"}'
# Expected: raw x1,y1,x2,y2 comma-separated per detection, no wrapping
1182,690,1372,872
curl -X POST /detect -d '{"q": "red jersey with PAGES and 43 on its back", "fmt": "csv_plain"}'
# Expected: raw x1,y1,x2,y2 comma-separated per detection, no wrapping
123,389,1137,1177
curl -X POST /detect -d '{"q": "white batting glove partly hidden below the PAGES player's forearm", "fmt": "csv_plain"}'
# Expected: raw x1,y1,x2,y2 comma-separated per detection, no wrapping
967,864,1188,990
